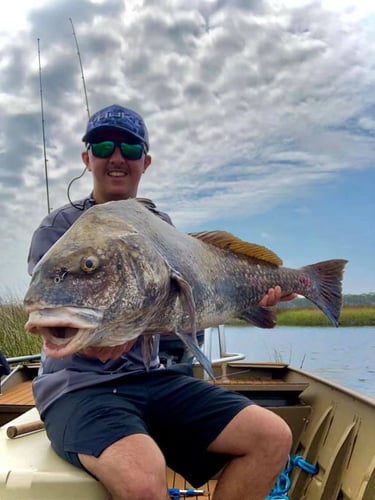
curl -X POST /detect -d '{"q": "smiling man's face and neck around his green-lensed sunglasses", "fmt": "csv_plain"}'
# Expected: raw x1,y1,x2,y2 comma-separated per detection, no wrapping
82,129,151,203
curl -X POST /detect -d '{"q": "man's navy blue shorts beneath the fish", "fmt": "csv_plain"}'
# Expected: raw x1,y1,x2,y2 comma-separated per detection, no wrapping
43,365,252,487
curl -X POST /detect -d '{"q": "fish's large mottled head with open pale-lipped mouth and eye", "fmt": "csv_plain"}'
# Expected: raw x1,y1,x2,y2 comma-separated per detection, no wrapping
24,211,170,358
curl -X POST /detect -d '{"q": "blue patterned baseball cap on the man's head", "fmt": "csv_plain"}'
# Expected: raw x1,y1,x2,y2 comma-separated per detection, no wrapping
82,104,149,150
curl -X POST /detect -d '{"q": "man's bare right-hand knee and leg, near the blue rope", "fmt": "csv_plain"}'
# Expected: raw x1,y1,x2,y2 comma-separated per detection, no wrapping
208,405,292,500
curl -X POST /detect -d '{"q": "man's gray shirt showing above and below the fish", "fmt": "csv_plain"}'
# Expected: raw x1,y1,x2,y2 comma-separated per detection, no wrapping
28,197,172,413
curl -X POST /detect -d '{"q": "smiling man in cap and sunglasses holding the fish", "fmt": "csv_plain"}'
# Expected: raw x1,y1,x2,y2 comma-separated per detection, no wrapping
29,105,293,500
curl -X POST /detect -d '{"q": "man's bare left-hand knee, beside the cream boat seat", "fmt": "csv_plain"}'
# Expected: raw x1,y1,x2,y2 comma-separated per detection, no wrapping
78,434,169,500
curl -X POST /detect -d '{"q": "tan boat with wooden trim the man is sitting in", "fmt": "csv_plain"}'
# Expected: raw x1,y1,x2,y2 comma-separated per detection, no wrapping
0,362,375,500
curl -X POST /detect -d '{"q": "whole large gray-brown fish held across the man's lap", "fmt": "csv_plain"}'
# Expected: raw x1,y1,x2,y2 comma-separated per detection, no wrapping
24,200,347,375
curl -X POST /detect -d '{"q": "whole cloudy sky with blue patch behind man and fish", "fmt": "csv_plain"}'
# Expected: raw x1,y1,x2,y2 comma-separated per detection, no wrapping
0,0,375,297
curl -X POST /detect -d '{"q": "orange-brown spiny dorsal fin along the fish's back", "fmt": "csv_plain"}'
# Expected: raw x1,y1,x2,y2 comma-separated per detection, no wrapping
189,231,283,266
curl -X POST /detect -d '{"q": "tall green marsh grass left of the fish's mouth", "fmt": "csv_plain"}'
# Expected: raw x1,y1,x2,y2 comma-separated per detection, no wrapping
0,300,42,358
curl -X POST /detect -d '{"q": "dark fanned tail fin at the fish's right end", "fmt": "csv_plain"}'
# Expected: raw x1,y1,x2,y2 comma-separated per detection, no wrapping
302,259,348,327
